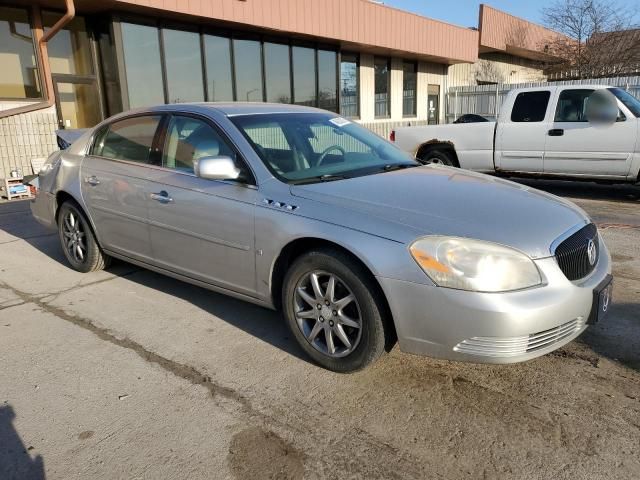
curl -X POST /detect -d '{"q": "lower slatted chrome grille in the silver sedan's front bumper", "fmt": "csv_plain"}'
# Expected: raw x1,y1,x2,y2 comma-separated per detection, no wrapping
453,317,585,357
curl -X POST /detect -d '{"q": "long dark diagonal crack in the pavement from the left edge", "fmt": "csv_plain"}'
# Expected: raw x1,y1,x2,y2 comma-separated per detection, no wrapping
0,282,259,415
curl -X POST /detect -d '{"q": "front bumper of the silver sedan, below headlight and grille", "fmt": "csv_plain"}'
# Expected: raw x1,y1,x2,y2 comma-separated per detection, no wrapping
378,239,611,363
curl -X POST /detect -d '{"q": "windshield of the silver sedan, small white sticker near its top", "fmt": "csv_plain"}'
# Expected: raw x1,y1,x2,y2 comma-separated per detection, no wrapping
230,113,419,184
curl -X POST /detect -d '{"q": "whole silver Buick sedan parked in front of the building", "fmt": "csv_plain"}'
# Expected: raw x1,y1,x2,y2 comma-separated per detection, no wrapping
32,103,611,372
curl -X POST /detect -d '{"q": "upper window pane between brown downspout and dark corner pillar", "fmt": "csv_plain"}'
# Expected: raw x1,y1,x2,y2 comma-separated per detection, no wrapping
42,12,93,75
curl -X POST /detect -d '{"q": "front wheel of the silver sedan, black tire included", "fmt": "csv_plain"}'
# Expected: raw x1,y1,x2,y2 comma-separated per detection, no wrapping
282,249,392,373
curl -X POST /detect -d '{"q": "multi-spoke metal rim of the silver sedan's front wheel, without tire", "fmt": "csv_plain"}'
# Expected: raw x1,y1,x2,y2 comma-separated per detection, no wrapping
293,270,362,357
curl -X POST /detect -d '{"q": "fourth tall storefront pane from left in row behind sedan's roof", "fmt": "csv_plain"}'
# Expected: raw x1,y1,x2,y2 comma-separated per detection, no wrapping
233,39,263,102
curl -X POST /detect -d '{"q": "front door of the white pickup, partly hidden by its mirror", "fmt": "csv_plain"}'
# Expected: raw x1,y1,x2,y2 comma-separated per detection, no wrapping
544,88,637,177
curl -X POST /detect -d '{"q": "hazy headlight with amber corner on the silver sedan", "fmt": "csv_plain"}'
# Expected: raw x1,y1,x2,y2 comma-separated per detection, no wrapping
409,236,542,292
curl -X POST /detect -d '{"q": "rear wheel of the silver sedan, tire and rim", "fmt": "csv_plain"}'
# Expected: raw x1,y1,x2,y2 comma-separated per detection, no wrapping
58,200,111,273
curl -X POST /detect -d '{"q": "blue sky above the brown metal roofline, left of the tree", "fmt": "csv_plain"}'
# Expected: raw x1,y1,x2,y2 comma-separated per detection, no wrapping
384,0,640,27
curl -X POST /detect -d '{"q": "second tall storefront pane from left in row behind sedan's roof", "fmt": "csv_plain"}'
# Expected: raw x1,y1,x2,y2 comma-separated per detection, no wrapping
162,29,204,103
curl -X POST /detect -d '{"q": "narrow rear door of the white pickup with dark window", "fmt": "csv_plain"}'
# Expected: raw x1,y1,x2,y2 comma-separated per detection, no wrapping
495,89,551,173
